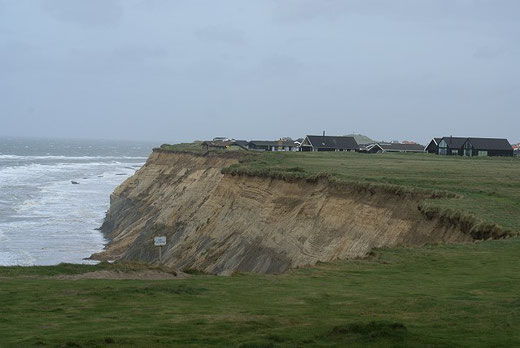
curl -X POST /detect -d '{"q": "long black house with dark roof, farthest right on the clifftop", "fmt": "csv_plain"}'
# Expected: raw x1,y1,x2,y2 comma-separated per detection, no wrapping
437,137,513,156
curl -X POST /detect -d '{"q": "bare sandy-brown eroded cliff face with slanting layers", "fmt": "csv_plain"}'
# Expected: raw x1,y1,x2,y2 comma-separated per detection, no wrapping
95,151,472,274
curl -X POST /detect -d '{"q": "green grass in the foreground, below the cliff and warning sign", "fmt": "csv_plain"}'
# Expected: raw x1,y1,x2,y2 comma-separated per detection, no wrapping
0,238,520,347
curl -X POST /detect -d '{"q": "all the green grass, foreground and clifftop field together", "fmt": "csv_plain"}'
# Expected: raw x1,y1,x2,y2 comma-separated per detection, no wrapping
0,149,520,347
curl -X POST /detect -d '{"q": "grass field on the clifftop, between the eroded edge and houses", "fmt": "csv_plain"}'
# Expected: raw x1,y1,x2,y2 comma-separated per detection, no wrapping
228,152,520,232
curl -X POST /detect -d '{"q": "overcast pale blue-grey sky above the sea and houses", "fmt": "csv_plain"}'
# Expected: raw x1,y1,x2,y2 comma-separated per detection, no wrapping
0,0,520,144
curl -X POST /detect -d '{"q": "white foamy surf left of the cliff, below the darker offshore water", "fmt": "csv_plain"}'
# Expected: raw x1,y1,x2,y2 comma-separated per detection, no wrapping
0,156,144,265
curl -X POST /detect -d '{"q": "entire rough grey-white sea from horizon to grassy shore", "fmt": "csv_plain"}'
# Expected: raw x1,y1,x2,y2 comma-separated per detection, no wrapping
0,137,154,266
